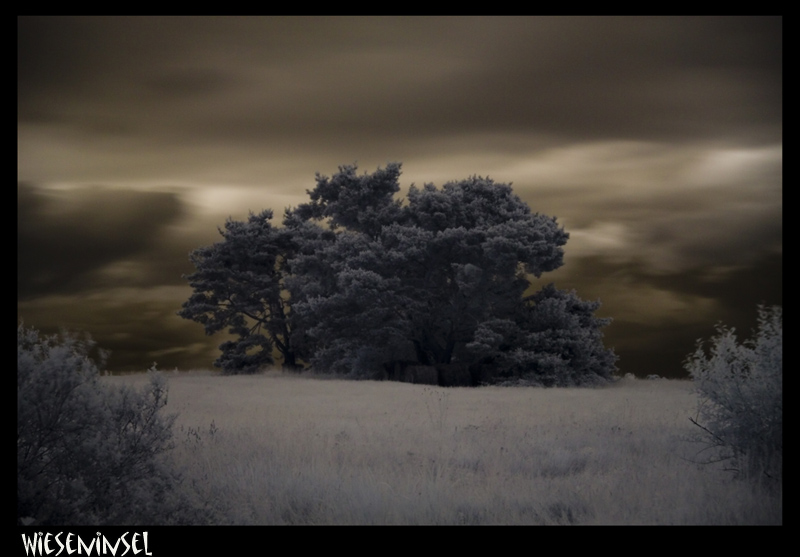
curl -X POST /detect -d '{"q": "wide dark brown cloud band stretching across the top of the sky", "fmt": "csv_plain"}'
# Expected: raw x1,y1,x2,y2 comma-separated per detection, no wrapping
18,17,782,149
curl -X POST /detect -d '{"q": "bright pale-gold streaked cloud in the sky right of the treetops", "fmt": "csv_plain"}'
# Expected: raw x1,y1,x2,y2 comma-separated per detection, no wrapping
494,142,783,272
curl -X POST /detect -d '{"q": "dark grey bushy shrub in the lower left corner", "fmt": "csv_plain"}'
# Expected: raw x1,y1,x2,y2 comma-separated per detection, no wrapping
17,325,209,525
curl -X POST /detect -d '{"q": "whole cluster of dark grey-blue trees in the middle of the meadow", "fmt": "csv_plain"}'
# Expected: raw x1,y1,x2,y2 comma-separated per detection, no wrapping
179,164,616,385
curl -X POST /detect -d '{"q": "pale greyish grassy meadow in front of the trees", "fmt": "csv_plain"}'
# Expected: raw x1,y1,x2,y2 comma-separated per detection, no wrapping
104,372,782,525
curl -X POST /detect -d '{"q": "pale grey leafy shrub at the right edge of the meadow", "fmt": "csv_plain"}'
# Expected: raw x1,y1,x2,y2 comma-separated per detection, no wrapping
685,306,783,481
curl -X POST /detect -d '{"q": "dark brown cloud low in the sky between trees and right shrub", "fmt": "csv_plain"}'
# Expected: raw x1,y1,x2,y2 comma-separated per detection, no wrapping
537,252,783,377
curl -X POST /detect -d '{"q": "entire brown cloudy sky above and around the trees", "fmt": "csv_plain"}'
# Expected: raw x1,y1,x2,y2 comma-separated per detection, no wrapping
17,17,783,376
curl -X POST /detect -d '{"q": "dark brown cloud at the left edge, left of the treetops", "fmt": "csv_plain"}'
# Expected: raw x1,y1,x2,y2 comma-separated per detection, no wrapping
17,183,181,299
